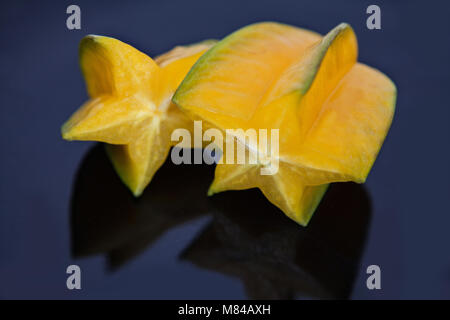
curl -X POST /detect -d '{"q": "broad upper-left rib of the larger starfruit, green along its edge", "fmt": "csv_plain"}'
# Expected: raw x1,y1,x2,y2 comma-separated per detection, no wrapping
175,23,320,128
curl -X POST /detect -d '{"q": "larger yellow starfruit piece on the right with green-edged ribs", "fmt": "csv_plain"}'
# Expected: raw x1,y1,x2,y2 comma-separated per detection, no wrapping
173,23,396,225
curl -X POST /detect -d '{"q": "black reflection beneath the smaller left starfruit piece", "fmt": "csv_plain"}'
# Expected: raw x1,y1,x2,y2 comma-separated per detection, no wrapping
71,144,214,269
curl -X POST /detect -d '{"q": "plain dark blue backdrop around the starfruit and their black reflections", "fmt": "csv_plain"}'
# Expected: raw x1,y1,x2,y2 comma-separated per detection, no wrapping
0,0,450,299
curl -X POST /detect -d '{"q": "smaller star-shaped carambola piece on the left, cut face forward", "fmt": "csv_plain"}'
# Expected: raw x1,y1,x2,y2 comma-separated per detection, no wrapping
62,36,212,196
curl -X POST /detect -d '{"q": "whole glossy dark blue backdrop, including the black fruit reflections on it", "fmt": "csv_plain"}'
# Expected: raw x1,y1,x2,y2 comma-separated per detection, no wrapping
0,0,450,299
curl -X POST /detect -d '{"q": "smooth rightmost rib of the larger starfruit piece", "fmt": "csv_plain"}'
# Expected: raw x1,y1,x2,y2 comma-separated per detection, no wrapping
297,63,396,183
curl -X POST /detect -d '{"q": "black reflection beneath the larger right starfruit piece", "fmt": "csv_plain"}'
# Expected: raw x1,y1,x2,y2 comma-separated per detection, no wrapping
181,182,371,299
